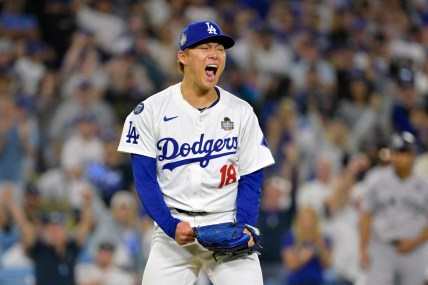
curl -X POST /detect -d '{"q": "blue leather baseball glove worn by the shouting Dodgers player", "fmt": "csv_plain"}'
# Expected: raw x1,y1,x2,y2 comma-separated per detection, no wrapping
193,222,261,259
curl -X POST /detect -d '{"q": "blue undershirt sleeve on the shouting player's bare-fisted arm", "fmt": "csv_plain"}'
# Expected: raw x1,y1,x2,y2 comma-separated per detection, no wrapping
131,154,181,239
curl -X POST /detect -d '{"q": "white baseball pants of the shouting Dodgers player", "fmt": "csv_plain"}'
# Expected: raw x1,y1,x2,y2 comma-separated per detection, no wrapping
142,211,263,285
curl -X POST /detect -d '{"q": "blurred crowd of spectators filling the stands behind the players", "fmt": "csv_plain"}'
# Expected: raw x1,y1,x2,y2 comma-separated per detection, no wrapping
0,0,428,285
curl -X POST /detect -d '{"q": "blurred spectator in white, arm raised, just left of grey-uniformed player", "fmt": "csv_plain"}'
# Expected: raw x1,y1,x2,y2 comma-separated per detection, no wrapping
323,154,370,285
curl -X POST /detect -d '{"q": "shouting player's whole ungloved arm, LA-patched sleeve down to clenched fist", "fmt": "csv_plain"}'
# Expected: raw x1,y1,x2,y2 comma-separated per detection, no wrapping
118,100,194,244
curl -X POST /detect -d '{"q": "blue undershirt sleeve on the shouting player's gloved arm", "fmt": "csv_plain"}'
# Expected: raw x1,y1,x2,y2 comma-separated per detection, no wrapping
236,168,264,226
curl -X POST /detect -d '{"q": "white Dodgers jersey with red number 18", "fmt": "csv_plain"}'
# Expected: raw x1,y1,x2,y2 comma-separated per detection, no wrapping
118,83,274,212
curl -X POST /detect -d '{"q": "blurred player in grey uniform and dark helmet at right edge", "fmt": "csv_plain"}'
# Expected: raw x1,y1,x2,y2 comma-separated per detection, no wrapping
360,132,428,285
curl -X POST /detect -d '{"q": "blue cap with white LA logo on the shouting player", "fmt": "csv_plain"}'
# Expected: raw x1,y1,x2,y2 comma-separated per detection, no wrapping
180,21,235,50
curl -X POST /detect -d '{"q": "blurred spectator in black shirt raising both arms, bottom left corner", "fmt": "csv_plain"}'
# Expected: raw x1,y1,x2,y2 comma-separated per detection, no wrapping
5,185,93,285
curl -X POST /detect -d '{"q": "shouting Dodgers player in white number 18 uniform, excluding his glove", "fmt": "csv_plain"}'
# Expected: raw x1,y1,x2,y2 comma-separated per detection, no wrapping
118,21,274,285
